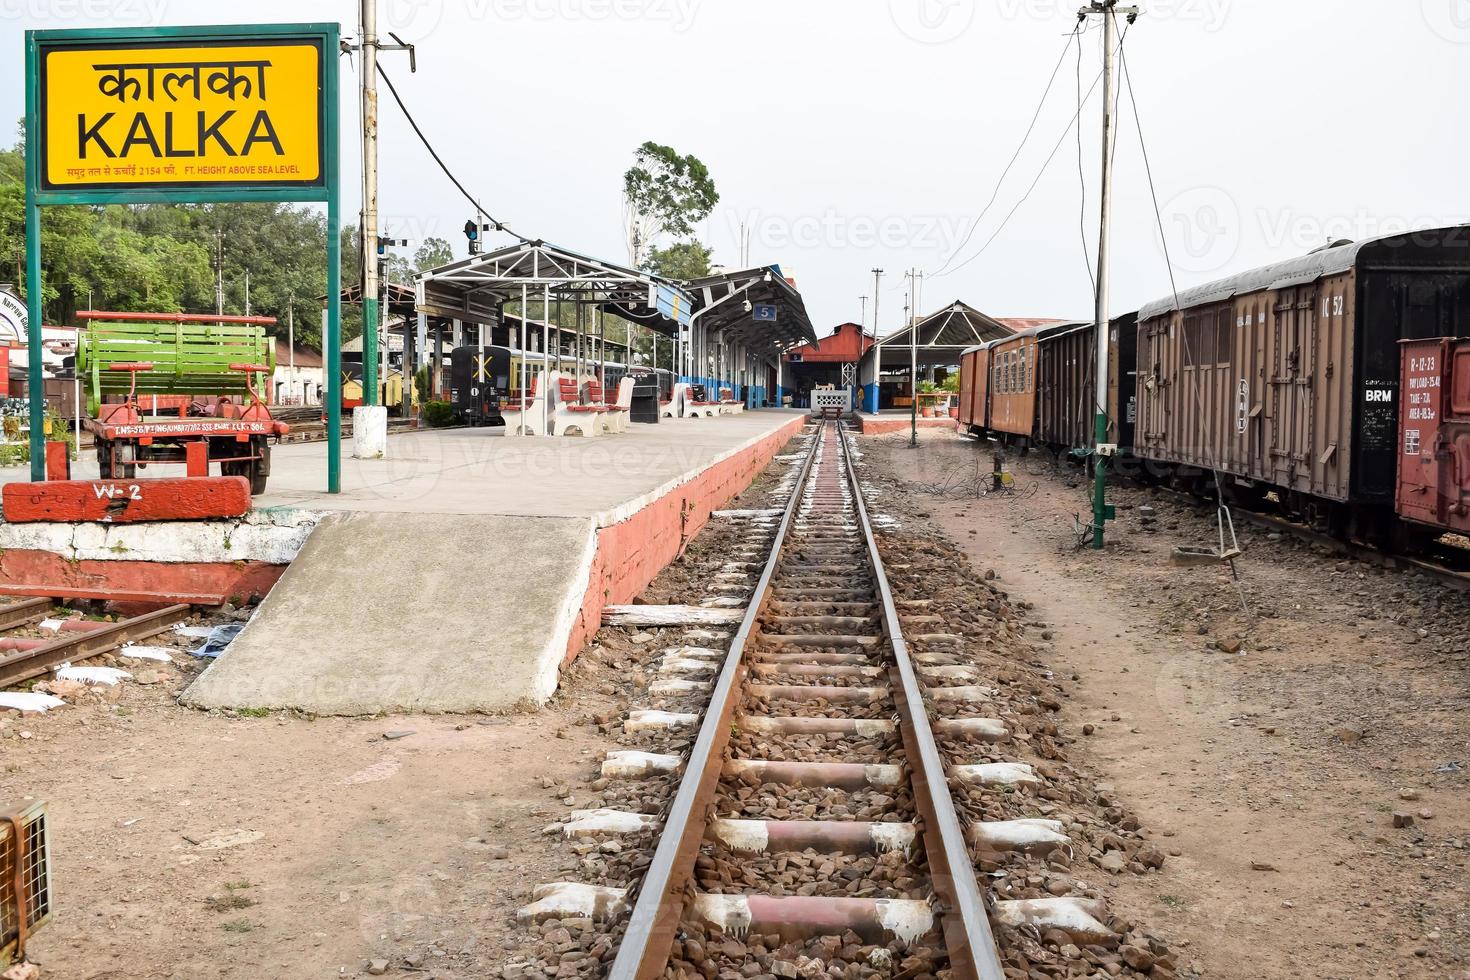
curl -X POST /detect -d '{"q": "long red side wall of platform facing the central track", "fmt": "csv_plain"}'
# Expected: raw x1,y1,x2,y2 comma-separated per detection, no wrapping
563,416,810,663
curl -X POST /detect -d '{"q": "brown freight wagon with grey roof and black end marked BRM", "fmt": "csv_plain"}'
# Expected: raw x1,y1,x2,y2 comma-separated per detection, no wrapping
1133,226,1470,533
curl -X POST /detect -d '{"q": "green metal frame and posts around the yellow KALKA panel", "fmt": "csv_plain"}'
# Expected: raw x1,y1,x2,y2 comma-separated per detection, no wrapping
25,24,343,494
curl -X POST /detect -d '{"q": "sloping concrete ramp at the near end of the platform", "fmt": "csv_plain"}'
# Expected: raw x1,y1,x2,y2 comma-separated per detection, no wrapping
182,513,597,714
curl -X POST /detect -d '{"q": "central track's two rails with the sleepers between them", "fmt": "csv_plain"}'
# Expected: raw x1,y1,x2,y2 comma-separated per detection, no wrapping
609,423,1004,980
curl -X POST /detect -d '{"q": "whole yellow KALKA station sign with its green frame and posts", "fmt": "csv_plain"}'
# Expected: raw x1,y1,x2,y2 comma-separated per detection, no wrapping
25,24,343,494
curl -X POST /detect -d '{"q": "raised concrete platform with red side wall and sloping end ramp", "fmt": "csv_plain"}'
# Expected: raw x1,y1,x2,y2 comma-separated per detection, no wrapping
184,410,806,716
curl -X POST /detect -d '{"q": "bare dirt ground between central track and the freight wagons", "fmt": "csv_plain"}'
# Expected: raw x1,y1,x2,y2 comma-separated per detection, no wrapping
861,430,1470,980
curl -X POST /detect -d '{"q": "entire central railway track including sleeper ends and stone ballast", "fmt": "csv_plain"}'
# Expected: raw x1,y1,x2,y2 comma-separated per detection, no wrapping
514,425,1158,980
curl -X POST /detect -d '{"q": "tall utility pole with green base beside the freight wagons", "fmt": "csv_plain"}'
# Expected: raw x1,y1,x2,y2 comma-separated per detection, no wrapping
1078,0,1138,551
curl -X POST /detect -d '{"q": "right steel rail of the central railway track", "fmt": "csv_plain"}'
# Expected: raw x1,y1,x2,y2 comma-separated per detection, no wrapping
838,428,1005,980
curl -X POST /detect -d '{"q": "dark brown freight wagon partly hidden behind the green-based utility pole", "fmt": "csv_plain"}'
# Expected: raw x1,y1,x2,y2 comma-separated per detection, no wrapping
1036,313,1138,454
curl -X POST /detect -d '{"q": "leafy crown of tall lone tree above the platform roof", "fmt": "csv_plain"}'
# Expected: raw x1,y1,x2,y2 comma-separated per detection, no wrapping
623,141,720,267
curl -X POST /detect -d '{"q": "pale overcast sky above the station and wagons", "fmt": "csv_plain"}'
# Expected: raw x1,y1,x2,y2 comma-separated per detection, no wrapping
0,0,1470,334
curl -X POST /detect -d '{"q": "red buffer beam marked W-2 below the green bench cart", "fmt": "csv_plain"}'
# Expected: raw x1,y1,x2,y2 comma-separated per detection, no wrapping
0,476,250,525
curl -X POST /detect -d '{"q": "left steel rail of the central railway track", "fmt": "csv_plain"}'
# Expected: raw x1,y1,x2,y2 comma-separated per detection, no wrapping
607,417,822,980
